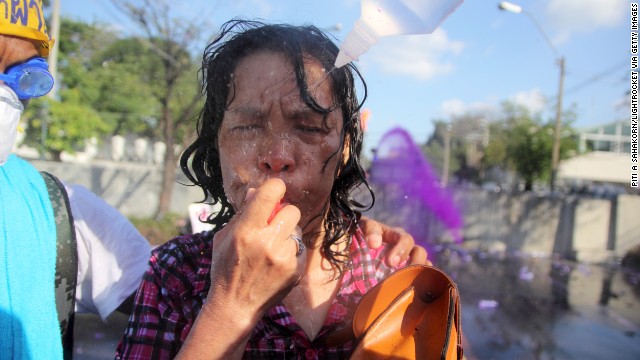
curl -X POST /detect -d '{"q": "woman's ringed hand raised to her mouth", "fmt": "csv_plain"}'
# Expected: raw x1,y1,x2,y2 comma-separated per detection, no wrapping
209,179,306,318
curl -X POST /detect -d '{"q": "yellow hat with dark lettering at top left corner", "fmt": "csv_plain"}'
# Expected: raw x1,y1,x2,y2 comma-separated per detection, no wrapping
0,0,53,56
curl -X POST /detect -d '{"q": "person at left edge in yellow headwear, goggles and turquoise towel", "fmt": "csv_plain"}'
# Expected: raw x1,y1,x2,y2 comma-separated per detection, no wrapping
0,0,151,359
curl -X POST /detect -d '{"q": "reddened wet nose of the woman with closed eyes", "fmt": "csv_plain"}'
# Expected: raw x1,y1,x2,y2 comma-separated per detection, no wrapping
258,134,295,174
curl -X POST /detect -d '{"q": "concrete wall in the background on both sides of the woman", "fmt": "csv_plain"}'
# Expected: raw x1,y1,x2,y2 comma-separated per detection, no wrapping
32,161,640,262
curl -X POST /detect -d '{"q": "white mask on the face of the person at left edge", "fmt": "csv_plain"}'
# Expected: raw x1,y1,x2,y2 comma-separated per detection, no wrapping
0,84,24,166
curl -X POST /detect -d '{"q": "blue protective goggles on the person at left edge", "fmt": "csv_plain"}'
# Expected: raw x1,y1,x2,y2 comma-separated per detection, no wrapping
0,57,53,100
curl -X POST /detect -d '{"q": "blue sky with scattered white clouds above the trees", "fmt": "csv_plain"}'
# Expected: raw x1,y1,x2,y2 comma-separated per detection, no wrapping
60,0,631,151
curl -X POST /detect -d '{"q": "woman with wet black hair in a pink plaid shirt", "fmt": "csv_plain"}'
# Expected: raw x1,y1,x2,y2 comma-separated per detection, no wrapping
117,20,426,359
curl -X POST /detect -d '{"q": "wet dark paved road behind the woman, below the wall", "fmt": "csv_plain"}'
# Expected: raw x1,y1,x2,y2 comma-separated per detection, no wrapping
74,251,640,360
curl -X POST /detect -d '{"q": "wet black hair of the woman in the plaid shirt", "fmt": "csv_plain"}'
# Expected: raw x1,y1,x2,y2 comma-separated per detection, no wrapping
180,19,375,271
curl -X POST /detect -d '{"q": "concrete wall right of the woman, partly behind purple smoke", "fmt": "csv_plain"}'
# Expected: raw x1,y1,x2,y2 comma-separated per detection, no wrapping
367,189,640,262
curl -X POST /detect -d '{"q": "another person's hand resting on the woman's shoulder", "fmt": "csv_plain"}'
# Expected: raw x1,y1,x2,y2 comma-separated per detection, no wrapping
359,216,433,266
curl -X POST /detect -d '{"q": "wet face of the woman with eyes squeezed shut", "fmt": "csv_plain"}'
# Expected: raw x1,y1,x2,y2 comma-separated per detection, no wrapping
218,51,342,229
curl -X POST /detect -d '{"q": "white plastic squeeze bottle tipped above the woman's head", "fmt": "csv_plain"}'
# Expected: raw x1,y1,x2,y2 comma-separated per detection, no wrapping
335,0,463,68
